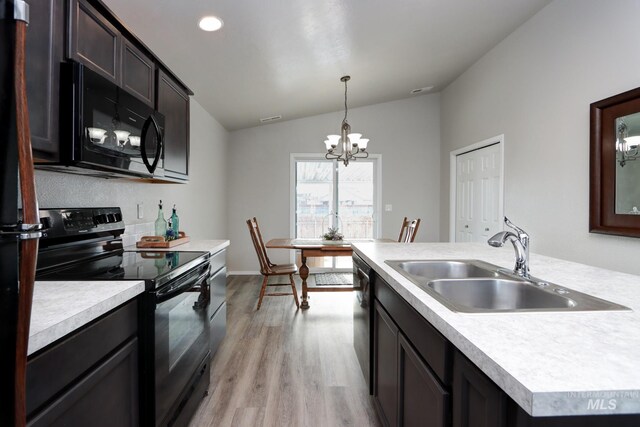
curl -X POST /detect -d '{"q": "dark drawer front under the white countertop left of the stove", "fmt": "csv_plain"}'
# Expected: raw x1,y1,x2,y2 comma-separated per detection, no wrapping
27,300,138,414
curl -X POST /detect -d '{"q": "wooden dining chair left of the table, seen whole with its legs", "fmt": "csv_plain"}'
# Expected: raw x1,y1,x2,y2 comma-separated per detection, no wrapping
247,217,300,310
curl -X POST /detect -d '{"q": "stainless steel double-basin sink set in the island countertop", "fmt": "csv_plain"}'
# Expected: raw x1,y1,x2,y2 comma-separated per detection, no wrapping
386,260,629,313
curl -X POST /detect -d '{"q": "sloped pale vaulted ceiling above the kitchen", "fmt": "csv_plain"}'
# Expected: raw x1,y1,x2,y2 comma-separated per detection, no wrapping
104,0,550,130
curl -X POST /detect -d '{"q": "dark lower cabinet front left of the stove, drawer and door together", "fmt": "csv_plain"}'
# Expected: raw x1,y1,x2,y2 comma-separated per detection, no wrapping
27,300,140,427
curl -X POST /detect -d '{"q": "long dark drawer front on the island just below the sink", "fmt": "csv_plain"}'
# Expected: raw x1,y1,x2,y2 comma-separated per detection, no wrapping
373,275,453,386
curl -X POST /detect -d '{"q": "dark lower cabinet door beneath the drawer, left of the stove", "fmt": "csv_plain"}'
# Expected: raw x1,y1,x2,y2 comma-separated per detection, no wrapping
28,338,139,427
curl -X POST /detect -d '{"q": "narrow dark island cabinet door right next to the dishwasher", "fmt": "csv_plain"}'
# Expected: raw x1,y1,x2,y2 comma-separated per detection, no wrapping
373,301,398,427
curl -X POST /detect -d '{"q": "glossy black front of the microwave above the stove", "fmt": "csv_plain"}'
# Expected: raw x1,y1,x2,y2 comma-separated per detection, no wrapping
73,64,164,176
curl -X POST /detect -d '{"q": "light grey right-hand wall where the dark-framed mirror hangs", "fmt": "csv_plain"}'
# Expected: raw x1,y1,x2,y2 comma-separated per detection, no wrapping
440,0,640,274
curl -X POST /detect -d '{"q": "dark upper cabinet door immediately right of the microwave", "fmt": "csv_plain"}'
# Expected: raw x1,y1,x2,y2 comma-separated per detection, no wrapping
157,70,189,179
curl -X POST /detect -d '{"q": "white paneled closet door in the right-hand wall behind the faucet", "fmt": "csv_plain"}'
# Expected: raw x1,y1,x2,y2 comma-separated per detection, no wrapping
455,144,502,242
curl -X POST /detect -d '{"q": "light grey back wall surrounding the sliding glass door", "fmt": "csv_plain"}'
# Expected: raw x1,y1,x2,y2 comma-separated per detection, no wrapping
228,94,440,271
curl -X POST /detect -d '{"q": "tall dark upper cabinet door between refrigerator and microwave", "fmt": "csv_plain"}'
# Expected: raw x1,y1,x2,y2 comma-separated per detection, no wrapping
25,0,64,161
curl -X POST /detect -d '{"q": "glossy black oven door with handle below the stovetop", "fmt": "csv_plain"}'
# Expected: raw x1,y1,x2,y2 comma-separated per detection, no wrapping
155,263,210,425
